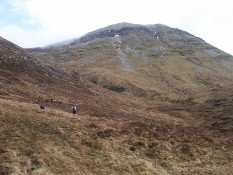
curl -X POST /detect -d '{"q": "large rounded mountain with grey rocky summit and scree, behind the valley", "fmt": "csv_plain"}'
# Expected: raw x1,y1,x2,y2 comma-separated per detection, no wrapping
31,23,233,102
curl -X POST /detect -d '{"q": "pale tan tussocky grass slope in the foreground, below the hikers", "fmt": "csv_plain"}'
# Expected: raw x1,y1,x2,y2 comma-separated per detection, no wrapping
0,99,233,175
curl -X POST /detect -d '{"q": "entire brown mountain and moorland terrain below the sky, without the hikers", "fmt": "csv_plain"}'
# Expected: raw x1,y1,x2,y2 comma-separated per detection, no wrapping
0,23,233,175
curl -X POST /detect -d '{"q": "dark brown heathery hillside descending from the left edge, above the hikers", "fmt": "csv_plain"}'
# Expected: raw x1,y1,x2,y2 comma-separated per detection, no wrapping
0,35,92,103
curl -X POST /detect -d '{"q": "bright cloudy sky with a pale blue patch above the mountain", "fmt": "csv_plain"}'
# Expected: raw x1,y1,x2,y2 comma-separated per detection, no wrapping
0,0,233,55
